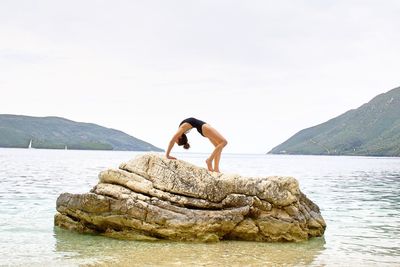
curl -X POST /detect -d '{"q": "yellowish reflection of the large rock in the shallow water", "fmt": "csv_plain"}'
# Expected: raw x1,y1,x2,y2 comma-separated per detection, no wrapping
54,227,325,266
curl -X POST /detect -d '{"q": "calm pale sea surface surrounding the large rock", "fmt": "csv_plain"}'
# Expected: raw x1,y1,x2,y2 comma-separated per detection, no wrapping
0,149,400,266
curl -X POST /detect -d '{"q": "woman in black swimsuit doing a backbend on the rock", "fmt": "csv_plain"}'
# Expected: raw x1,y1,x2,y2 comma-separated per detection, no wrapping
166,118,228,172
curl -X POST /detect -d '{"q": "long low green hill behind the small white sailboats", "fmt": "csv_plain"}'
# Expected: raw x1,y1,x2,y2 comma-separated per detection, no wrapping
0,114,162,151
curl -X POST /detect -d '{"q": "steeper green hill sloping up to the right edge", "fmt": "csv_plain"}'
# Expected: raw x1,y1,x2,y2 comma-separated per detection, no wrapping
268,87,400,157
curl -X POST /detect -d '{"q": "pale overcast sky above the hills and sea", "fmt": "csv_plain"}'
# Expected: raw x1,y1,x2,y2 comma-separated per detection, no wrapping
0,0,400,154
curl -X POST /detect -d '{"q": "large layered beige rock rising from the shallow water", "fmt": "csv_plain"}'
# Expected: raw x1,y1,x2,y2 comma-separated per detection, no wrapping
55,154,326,241
